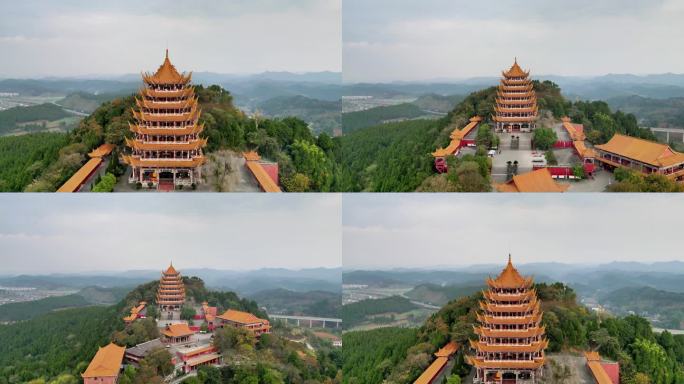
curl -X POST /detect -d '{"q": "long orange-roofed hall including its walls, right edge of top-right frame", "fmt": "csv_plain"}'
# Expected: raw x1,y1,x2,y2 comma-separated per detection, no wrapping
594,133,684,181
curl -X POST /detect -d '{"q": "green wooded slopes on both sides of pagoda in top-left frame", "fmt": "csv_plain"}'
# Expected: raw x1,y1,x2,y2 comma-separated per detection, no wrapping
0,86,339,192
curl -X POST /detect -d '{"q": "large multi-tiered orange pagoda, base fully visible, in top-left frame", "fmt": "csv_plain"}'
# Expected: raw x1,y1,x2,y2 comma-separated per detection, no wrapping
124,50,207,190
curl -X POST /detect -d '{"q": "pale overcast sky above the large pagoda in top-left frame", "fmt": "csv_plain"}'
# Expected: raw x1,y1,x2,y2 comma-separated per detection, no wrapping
0,0,342,77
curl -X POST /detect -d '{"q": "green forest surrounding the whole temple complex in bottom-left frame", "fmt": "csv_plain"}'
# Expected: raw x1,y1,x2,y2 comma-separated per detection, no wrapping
0,277,340,383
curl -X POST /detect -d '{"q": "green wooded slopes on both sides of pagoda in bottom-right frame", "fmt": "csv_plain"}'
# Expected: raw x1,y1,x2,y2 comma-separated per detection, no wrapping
344,283,684,384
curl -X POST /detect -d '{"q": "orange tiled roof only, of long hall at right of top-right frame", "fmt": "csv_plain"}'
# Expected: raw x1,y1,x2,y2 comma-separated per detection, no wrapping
596,133,684,167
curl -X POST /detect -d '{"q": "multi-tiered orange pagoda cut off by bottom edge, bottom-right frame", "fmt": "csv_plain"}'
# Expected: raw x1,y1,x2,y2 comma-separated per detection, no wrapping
468,255,548,384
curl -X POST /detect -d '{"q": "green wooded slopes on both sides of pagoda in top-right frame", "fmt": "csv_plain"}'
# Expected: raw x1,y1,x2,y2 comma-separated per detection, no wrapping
338,81,655,192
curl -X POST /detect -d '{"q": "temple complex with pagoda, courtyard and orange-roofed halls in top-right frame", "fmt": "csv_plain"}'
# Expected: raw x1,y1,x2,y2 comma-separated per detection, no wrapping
432,58,684,192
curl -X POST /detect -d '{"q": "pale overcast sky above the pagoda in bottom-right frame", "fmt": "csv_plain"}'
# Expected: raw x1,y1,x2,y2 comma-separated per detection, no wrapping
342,193,684,269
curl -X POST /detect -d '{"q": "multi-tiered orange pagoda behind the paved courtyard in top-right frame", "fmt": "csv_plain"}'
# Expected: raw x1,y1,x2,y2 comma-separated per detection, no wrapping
492,59,538,132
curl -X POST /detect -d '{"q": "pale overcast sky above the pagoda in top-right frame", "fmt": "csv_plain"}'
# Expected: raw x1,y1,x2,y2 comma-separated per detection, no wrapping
342,0,684,82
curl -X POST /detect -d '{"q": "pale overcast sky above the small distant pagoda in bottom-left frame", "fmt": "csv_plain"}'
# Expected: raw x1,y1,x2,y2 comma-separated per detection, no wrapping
0,193,342,274
